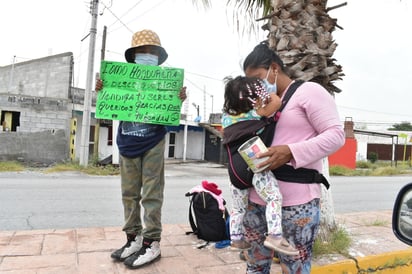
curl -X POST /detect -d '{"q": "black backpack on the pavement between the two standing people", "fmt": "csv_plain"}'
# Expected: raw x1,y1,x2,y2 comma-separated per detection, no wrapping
185,191,230,242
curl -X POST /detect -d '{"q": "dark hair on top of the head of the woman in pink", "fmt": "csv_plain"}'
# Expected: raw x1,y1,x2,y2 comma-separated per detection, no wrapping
243,41,285,71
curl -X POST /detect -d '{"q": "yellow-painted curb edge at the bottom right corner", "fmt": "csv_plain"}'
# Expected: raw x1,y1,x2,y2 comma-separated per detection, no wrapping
311,248,412,274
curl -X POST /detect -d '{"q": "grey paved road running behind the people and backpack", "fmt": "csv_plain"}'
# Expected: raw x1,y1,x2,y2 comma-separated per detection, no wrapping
0,163,412,230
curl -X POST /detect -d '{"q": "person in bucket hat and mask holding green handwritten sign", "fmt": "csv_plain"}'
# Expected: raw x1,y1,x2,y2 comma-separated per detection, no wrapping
96,30,186,268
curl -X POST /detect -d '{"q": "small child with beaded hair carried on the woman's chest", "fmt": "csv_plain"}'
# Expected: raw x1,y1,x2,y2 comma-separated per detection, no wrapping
222,76,299,255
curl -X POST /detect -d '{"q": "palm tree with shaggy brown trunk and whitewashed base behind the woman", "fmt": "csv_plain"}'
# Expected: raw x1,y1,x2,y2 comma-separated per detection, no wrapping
193,0,346,240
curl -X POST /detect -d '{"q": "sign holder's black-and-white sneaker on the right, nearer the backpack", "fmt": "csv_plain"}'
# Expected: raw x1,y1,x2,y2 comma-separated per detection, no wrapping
124,241,160,269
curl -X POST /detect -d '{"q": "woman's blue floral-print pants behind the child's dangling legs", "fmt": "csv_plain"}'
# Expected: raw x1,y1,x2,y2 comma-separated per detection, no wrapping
243,199,320,274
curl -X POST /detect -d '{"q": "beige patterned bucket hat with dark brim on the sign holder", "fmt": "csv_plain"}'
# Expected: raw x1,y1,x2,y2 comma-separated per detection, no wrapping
124,29,168,65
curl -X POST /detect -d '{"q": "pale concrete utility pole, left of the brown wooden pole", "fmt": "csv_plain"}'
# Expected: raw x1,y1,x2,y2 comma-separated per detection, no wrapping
80,0,99,166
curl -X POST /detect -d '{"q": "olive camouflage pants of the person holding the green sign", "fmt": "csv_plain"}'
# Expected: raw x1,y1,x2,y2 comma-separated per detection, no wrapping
120,139,165,240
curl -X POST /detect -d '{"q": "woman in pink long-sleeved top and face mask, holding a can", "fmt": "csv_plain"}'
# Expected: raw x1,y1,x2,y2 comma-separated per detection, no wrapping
243,43,345,274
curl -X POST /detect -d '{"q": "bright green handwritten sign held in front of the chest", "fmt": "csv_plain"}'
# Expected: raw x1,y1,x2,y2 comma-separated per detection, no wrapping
96,61,184,125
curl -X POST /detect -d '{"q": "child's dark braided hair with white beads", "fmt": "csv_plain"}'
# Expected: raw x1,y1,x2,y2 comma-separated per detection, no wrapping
223,76,269,115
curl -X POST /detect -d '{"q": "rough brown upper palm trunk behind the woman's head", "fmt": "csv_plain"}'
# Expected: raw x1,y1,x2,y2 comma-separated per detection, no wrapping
264,0,346,94
